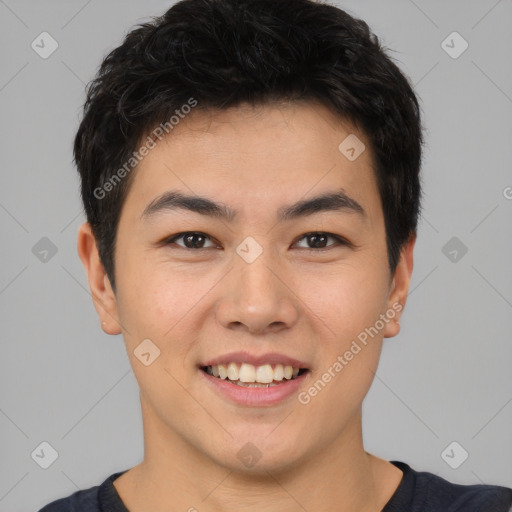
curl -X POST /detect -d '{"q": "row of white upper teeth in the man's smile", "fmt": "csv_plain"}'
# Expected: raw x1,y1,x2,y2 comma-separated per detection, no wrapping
207,363,299,384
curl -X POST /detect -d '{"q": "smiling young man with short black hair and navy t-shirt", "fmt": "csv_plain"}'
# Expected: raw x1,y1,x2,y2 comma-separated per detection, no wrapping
41,0,512,512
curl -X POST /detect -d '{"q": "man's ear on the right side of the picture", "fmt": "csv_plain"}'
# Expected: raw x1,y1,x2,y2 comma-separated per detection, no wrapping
384,235,416,338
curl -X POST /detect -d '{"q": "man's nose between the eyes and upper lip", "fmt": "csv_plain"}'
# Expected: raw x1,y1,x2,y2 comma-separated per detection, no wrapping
216,251,299,334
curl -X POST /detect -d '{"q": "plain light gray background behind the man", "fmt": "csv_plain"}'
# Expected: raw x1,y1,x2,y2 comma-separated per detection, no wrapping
0,0,512,512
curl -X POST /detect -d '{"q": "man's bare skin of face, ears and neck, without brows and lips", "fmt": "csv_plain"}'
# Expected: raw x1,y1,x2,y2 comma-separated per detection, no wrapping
78,103,415,512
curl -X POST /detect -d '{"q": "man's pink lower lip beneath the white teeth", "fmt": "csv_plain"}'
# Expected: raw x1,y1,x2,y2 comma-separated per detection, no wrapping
199,369,309,407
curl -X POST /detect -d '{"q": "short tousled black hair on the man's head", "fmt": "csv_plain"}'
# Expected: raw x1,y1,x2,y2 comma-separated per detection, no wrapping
73,0,423,290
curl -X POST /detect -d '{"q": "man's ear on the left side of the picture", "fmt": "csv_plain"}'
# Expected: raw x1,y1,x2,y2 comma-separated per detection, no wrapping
77,222,121,334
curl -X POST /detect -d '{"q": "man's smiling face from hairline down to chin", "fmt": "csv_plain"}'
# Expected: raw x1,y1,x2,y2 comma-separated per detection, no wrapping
82,104,413,471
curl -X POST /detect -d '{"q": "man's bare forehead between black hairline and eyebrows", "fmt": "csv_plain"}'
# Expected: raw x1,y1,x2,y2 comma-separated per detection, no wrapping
125,103,380,225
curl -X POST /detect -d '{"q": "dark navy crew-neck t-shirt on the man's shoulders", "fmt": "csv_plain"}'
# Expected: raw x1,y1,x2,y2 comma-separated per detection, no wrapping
38,461,512,512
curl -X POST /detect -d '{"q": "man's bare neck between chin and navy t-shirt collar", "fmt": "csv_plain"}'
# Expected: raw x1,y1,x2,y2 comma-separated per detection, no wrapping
114,401,402,512
